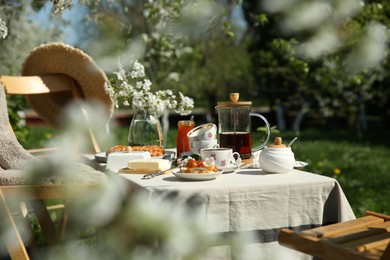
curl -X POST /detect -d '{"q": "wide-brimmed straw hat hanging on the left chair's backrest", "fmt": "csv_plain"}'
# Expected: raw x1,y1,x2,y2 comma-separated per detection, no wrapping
22,43,114,127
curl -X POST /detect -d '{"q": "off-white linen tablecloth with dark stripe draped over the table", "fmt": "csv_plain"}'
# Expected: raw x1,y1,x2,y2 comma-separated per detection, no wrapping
120,169,355,259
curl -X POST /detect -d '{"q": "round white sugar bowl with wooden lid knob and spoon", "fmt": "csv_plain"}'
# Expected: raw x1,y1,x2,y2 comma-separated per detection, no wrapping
259,137,295,173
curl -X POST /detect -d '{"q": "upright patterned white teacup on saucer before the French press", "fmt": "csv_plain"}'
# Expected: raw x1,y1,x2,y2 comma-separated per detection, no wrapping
200,148,241,168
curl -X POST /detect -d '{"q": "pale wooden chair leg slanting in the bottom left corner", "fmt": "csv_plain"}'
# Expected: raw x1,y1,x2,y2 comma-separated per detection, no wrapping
0,190,30,259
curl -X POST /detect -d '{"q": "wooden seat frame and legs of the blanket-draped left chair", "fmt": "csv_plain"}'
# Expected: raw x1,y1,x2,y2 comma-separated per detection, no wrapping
0,185,104,259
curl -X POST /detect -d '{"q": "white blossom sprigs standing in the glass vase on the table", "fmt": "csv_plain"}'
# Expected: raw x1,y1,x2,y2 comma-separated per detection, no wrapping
105,60,194,117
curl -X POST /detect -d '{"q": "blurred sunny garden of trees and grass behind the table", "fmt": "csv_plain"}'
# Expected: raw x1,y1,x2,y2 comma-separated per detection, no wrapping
0,0,390,219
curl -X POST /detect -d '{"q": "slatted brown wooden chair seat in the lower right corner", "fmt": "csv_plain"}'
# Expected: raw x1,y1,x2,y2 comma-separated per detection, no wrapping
279,211,390,260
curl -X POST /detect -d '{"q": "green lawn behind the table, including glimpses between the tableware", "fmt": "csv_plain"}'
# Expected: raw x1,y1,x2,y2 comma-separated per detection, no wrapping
26,124,390,217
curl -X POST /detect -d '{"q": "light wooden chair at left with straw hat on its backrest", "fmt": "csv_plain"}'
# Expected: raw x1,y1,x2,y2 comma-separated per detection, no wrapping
0,75,106,259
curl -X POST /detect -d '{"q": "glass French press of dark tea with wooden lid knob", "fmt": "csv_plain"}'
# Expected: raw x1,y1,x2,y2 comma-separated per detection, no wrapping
216,93,270,159
